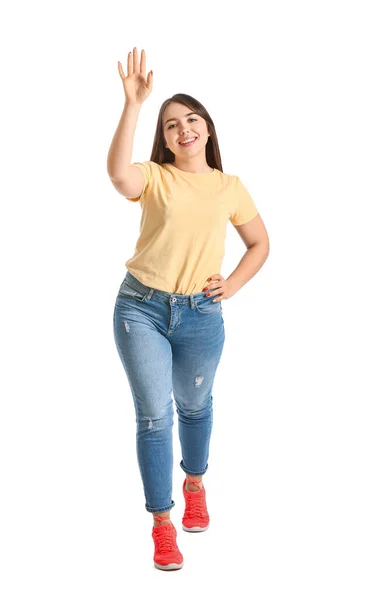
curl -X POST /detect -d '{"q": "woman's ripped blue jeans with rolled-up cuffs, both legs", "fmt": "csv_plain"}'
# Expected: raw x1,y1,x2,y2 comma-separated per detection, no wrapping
113,271,225,512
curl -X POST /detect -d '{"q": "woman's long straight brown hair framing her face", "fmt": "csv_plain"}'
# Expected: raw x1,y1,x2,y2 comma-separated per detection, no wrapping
150,94,223,172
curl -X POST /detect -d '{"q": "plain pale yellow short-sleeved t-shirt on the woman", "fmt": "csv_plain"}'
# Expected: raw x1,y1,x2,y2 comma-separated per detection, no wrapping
125,161,258,294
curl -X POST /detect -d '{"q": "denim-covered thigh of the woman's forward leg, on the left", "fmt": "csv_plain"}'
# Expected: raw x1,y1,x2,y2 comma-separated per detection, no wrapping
113,294,173,418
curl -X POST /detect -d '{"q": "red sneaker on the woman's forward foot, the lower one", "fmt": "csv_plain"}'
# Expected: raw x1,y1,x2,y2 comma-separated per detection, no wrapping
152,516,184,571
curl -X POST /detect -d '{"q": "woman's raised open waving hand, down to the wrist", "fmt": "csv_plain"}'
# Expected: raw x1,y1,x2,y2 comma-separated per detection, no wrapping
118,48,153,104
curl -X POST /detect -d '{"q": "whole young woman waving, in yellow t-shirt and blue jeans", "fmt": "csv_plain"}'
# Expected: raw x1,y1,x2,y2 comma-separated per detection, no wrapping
107,48,269,570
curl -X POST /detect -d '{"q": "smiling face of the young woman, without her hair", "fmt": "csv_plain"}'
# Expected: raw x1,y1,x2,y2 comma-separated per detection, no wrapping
162,102,210,161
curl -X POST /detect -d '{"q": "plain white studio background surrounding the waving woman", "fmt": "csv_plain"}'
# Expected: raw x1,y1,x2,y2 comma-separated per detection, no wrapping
0,0,365,600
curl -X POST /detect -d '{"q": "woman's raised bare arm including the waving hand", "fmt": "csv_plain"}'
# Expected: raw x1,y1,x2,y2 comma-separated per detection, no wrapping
107,48,152,198
